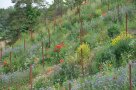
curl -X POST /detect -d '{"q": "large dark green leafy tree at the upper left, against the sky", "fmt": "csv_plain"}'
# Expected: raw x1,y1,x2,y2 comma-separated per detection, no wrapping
8,0,42,39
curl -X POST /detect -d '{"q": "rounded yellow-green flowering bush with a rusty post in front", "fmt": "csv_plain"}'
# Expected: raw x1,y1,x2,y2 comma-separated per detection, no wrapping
77,43,91,58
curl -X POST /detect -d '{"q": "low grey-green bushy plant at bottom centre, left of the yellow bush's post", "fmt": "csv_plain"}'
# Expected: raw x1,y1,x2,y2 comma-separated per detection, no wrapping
51,63,80,85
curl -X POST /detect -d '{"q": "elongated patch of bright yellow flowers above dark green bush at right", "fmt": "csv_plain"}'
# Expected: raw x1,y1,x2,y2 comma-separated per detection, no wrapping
111,32,133,46
